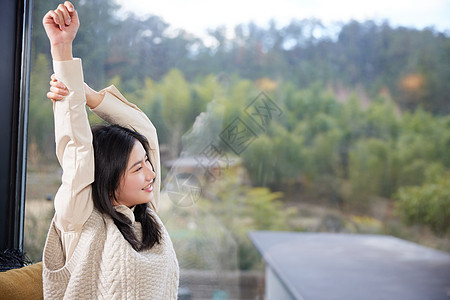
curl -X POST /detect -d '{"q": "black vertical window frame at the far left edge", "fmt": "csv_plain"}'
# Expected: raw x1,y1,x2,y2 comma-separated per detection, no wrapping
0,0,33,251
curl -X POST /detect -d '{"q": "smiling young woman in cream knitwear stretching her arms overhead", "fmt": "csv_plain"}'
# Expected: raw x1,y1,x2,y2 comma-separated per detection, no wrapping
43,1,179,299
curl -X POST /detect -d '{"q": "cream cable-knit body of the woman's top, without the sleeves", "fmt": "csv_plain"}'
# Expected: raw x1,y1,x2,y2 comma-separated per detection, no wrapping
43,209,179,300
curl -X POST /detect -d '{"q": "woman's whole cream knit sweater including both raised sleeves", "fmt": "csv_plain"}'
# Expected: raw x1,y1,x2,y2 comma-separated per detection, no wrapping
43,59,179,300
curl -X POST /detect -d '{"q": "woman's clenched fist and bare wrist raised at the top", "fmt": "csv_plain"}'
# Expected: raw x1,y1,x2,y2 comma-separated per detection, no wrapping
42,1,80,60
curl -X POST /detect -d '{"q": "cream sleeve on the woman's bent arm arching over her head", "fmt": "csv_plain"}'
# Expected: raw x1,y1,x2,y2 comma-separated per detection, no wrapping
92,86,161,211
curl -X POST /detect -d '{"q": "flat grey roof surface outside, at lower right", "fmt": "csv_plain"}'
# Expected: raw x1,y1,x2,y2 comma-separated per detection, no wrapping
249,231,450,300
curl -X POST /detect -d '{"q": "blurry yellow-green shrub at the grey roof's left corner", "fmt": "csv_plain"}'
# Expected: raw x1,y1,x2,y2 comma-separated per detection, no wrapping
199,174,299,270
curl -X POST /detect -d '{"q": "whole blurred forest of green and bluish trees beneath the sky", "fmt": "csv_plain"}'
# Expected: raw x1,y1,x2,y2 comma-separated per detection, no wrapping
28,0,450,269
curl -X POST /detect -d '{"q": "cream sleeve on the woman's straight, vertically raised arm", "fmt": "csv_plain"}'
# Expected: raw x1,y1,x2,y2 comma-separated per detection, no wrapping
53,59,94,260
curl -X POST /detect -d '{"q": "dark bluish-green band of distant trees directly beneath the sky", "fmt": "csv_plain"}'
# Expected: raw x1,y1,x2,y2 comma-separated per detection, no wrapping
32,0,450,114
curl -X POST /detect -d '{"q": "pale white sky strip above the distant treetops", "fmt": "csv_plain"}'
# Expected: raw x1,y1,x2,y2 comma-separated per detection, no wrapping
116,0,450,41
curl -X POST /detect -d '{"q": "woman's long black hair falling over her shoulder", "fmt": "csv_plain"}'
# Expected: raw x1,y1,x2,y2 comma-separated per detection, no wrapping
92,125,161,251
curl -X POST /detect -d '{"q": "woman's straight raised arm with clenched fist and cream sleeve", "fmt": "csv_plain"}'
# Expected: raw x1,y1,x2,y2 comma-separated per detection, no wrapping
43,1,94,259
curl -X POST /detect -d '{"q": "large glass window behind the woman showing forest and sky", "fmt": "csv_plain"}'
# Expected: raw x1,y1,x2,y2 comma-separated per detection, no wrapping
25,0,450,299
